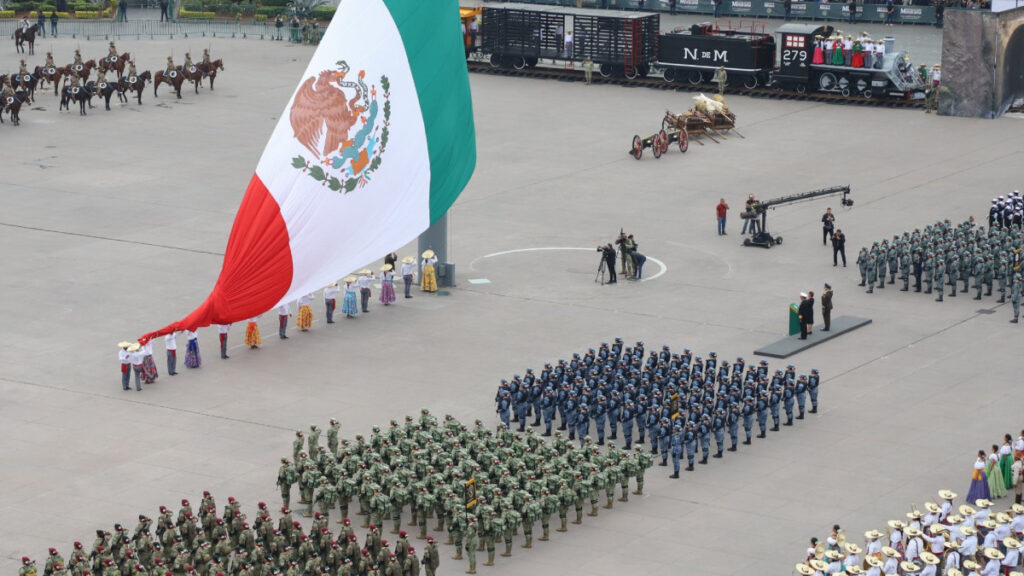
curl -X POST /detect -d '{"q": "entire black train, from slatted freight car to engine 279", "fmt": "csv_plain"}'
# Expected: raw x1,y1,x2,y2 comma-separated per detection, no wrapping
468,3,925,98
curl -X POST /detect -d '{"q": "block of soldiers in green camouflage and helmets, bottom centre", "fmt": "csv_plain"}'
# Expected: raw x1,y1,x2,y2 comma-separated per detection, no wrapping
276,409,652,576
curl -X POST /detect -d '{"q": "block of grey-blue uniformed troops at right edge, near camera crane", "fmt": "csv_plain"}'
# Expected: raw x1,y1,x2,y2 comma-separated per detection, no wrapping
857,215,1024,323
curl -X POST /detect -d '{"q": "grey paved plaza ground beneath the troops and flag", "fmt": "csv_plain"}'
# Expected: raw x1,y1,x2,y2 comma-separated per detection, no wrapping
0,24,1024,576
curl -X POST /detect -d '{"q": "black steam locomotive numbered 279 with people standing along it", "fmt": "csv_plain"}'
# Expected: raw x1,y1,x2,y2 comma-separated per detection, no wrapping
774,24,925,98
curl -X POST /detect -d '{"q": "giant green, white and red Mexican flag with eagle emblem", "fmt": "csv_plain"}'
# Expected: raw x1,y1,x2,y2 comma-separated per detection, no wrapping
141,0,476,341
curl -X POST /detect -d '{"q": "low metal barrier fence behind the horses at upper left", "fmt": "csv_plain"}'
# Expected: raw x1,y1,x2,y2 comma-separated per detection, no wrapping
0,18,288,39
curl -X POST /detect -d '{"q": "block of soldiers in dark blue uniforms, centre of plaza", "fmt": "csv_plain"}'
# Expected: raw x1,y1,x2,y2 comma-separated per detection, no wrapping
495,338,820,478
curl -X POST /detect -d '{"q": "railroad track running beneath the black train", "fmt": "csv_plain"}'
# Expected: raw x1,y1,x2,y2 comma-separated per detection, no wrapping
467,59,925,110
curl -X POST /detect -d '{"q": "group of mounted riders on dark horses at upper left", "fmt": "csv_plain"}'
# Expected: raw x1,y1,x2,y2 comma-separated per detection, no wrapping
0,42,224,126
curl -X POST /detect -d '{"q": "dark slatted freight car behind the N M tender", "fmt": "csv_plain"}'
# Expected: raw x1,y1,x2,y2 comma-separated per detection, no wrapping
480,3,660,78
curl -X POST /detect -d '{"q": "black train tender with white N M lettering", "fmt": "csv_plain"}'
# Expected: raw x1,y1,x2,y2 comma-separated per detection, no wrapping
657,23,775,88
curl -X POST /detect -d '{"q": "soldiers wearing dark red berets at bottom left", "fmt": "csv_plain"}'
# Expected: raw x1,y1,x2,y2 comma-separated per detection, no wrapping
12,492,440,576
